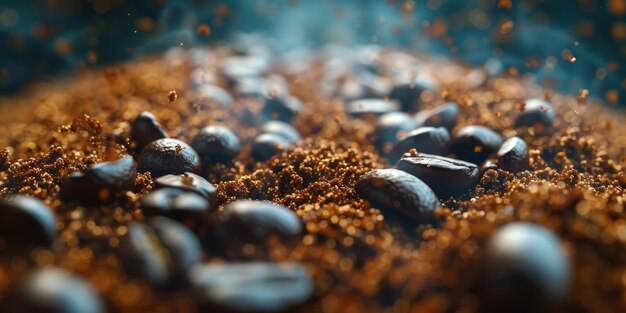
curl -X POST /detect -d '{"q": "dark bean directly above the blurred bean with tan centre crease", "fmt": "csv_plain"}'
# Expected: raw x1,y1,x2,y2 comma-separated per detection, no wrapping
141,188,210,229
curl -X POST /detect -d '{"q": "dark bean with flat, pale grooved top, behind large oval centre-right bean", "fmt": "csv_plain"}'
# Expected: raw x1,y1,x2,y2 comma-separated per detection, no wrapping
396,153,478,199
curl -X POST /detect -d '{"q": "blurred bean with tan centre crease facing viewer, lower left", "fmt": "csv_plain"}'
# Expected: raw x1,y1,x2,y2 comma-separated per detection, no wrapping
119,216,201,287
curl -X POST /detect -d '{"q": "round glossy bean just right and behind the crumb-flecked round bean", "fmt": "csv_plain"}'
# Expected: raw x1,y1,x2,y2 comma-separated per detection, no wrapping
191,126,241,163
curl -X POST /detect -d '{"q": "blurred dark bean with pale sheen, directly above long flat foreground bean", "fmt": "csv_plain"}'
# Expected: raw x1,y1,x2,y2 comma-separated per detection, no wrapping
211,200,302,249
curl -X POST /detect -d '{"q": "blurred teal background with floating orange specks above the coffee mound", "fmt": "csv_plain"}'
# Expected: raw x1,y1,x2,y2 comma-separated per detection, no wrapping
0,0,626,107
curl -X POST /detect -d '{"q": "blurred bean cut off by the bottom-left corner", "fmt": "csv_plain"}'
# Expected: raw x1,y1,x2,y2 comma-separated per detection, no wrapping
2,267,106,313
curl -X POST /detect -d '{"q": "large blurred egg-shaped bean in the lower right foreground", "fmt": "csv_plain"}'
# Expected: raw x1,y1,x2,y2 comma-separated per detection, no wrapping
480,223,570,313
